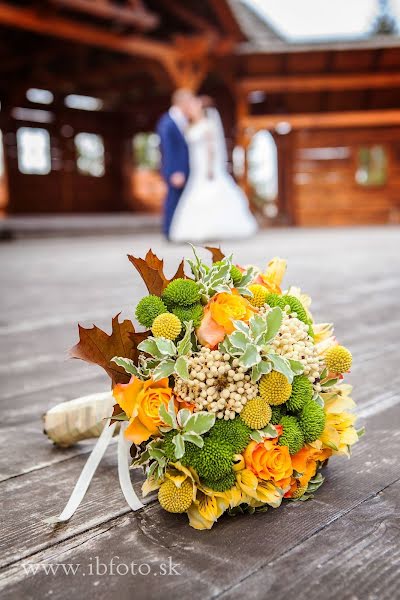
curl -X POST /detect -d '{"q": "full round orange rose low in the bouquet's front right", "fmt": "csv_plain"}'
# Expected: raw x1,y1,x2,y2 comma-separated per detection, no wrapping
243,439,293,489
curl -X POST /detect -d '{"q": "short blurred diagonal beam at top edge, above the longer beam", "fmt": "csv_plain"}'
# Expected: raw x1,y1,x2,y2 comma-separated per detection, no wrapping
51,0,159,31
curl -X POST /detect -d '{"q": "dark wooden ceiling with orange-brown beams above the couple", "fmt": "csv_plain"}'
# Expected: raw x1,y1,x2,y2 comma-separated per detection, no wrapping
0,0,400,116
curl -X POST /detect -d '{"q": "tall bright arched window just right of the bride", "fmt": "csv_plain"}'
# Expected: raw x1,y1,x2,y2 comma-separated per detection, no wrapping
247,131,278,218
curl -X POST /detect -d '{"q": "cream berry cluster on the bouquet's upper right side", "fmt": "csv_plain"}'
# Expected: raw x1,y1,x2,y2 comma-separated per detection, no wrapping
265,306,321,383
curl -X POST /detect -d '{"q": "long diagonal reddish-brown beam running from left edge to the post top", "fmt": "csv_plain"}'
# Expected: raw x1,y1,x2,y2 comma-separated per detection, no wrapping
0,2,177,65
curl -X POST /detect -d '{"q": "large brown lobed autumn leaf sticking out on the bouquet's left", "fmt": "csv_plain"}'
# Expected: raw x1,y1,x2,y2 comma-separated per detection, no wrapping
69,314,143,385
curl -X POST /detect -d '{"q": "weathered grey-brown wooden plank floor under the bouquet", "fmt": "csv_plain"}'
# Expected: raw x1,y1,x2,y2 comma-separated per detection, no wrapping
0,228,400,600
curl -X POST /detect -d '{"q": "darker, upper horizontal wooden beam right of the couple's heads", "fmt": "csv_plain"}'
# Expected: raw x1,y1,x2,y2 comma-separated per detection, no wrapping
237,72,400,94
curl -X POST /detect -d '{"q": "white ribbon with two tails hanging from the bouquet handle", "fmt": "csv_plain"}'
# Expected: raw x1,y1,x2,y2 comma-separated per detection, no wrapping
45,419,144,525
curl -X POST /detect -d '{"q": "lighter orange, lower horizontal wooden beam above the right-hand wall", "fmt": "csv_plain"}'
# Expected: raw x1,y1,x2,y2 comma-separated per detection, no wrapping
239,109,400,133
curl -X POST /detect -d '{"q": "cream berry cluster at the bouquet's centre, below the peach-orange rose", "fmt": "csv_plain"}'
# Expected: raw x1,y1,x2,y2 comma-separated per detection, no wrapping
174,347,257,420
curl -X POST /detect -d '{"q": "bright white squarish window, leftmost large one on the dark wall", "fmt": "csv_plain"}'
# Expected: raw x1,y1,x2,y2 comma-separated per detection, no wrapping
17,127,51,175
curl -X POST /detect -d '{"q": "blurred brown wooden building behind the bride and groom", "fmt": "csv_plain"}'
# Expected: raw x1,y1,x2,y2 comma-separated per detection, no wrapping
0,0,400,225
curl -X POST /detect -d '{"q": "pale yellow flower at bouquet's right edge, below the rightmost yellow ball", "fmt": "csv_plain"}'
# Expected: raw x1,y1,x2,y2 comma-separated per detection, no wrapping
320,384,358,456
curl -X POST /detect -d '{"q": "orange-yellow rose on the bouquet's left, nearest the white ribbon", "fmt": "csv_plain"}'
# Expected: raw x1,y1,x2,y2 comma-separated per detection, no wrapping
113,376,172,444
